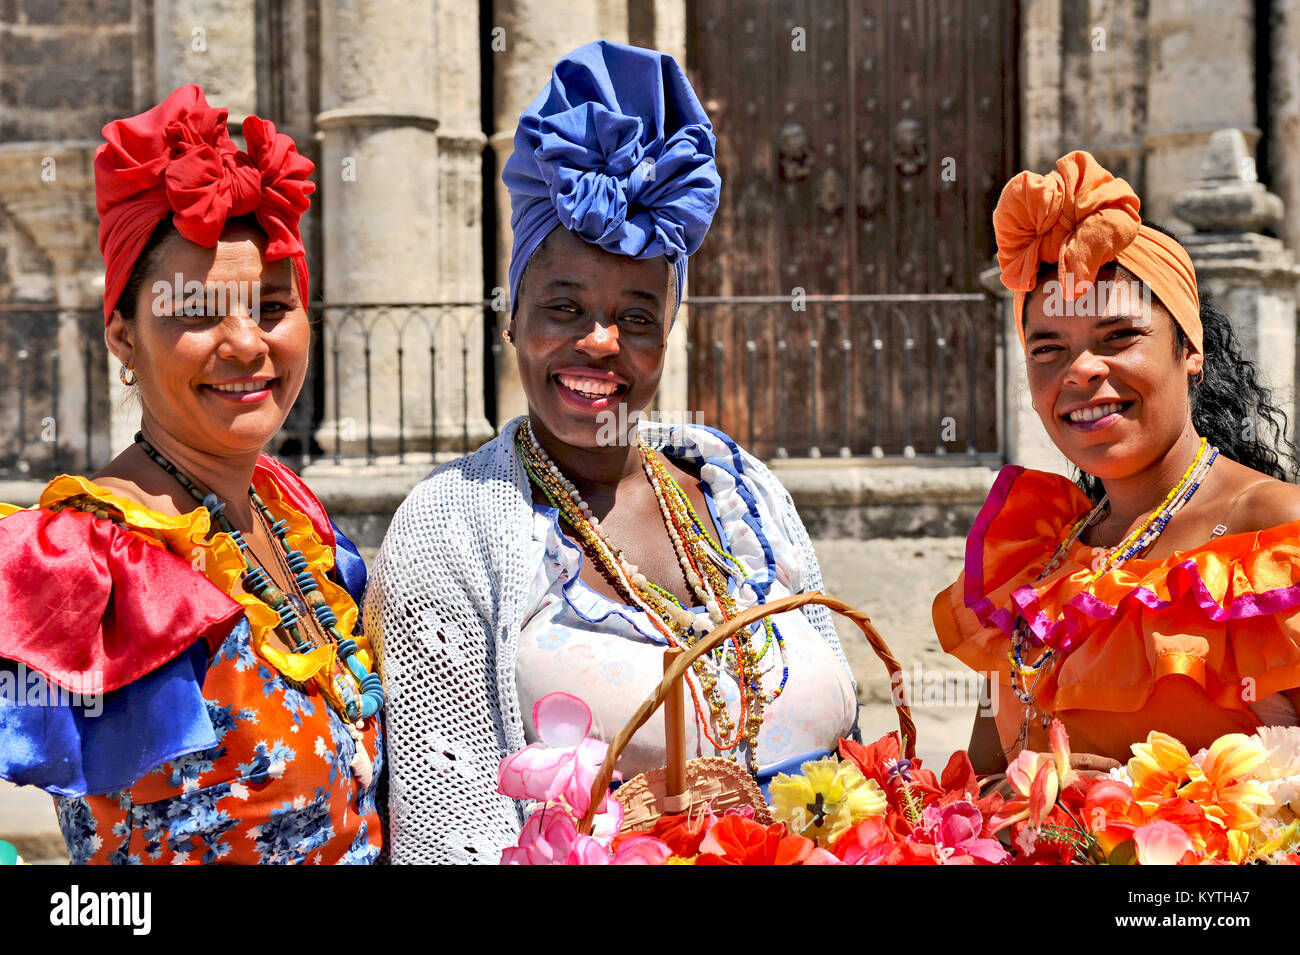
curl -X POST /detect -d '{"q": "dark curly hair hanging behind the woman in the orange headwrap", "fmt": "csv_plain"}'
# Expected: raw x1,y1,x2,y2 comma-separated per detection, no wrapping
1075,222,1300,502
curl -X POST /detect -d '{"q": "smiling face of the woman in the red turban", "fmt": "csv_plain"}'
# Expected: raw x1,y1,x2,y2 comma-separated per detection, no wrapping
105,223,311,455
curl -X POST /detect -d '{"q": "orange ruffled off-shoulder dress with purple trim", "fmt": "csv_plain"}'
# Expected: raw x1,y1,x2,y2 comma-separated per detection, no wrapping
933,466,1300,760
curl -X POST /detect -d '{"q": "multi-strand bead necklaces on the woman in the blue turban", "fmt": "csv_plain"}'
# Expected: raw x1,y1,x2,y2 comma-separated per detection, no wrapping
515,420,789,770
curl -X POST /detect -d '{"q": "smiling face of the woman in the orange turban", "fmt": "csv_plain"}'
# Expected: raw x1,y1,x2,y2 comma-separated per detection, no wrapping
1024,266,1203,479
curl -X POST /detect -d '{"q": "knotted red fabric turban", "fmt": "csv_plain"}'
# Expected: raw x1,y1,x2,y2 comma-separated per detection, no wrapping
95,84,316,324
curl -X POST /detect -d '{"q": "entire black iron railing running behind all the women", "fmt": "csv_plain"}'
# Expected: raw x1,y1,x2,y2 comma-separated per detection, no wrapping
0,295,1001,479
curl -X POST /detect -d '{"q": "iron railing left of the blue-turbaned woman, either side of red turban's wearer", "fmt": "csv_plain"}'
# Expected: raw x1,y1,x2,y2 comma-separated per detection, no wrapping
0,301,501,479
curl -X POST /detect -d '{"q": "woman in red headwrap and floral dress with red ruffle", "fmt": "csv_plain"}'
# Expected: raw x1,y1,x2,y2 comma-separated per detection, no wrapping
0,86,384,864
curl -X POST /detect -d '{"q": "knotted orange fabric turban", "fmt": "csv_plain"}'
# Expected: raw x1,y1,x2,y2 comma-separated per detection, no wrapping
993,149,1204,351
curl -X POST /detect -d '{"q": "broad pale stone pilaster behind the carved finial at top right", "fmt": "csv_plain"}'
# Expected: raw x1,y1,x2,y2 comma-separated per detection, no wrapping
1141,0,1260,230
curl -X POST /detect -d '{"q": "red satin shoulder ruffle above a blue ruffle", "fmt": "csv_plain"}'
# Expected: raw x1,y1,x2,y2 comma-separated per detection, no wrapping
0,509,243,693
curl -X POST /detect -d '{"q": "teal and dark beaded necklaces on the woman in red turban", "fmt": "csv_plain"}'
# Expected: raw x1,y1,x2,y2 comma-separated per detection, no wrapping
135,431,384,786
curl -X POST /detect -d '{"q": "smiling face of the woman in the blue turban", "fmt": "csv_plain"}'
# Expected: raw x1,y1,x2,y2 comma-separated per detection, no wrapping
512,227,675,448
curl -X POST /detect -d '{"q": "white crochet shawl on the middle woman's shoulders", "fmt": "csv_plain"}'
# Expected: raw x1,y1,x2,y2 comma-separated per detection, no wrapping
365,418,848,864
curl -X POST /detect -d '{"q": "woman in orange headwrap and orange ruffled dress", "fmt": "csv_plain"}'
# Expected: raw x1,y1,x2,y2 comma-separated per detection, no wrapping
933,152,1300,772
